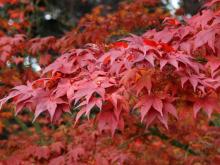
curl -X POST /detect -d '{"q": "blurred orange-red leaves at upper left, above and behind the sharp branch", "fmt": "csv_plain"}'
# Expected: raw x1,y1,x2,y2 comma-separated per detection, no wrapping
0,0,168,134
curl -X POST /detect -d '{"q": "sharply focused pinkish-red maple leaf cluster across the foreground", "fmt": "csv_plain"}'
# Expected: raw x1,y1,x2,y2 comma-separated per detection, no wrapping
0,0,220,134
